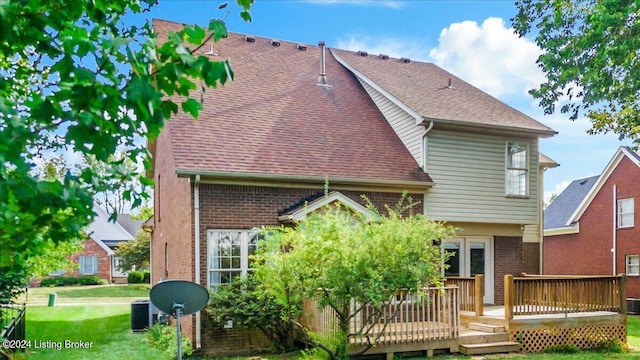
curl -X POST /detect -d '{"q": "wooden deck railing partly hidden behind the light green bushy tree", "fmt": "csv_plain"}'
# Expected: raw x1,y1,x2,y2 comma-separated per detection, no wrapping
301,286,460,346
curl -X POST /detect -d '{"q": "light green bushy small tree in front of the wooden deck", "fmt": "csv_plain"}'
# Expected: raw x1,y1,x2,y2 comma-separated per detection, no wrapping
254,197,453,359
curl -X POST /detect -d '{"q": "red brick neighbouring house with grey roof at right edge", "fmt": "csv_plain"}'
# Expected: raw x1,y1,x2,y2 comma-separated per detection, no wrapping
543,147,640,297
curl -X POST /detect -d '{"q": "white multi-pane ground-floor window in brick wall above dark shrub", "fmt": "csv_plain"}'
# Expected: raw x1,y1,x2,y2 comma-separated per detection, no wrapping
207,230,260,287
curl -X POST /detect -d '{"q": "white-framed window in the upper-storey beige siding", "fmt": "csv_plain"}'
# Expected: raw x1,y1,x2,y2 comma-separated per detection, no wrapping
505,142,529,196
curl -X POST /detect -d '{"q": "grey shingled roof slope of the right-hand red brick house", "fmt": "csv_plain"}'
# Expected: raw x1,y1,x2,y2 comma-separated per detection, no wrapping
544,175,600,231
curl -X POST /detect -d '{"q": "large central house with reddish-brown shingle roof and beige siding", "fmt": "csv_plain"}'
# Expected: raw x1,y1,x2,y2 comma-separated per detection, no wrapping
149,20,557,355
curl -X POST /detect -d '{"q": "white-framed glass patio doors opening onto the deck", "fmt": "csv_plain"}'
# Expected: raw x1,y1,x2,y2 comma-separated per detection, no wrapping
444,237,494,304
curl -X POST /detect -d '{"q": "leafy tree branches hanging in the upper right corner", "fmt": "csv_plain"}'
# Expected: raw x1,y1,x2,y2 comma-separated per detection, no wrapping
512,0,640,145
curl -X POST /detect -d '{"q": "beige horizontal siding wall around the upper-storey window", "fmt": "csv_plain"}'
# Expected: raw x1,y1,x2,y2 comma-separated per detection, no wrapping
425,129,538,224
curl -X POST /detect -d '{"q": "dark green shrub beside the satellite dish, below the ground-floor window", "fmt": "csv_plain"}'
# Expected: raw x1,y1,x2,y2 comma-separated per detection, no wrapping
206,276,302,352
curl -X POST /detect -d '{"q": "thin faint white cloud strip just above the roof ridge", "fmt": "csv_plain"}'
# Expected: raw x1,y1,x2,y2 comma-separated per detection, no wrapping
336,34,429,61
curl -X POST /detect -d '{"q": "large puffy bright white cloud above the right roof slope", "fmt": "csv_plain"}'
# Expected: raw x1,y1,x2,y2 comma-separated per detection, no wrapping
430,17,544,97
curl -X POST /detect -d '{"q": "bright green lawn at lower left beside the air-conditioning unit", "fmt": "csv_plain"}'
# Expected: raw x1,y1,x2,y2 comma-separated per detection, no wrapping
26,304,170,360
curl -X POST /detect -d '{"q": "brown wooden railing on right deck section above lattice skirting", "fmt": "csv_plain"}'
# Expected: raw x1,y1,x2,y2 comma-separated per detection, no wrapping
504,275,626,319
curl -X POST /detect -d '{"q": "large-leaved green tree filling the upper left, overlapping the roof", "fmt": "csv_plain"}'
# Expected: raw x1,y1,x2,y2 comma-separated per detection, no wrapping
0,0,252,299
